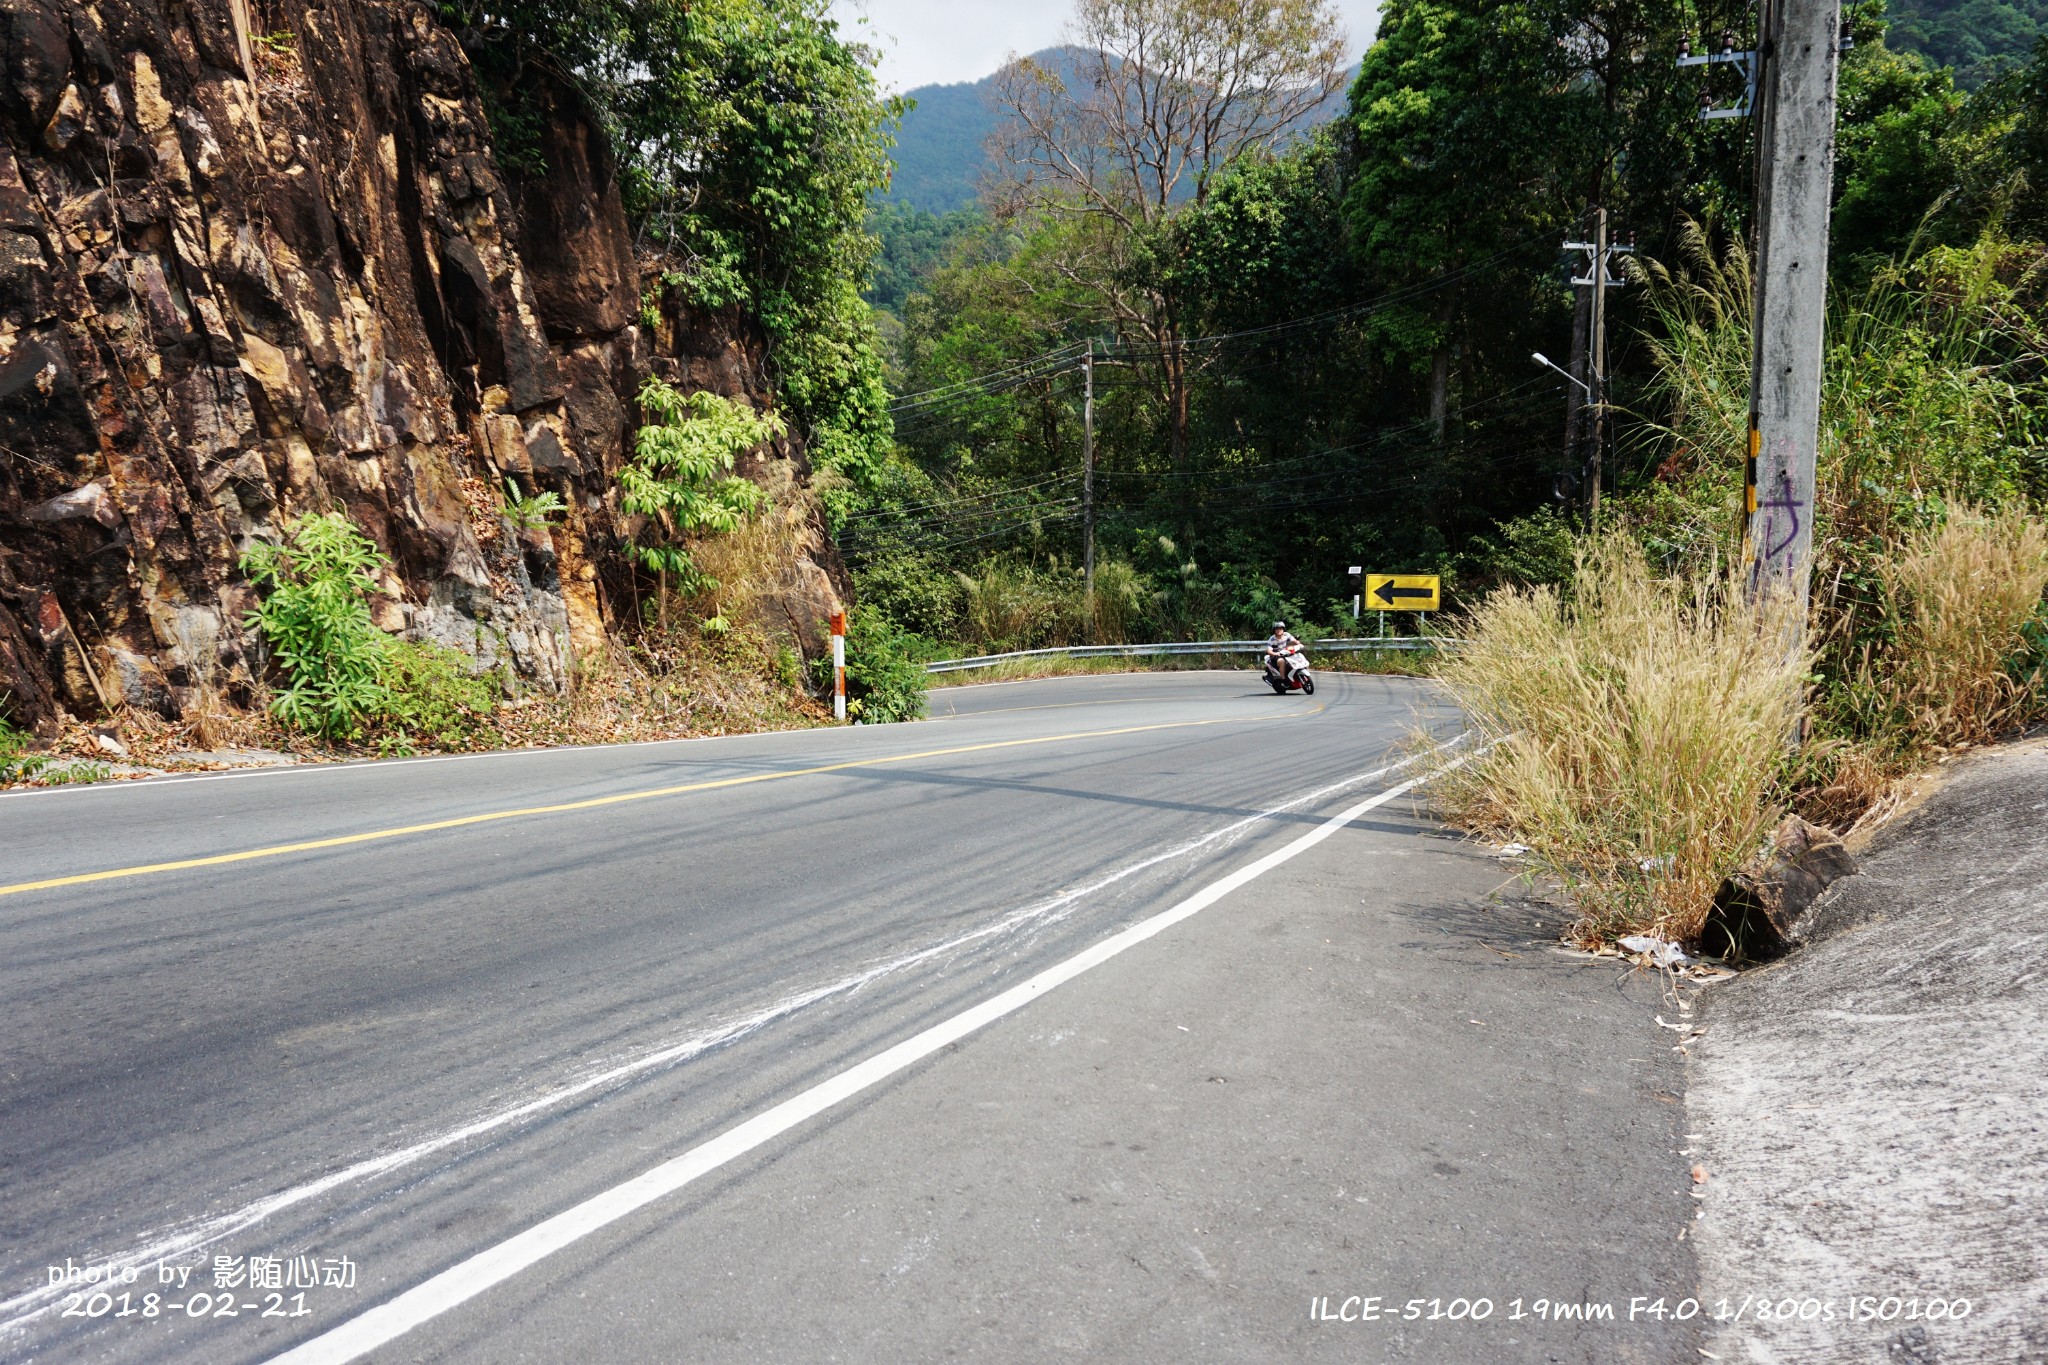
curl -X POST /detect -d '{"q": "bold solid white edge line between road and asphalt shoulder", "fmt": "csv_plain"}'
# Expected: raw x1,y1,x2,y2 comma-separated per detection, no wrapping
272,755,1470,1365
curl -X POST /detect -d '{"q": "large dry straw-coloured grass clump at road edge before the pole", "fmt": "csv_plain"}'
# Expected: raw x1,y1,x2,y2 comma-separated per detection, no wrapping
1438,536,1808,943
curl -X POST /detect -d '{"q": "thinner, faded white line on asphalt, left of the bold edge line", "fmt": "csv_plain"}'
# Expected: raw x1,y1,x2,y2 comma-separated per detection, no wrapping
0,737,1462,1334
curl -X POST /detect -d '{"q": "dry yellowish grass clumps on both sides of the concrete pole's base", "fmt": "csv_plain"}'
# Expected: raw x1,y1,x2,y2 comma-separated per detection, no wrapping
1438,517,2048,945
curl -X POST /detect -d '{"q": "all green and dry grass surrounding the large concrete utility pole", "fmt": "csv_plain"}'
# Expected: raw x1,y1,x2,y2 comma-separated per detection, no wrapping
1442,231,2048,943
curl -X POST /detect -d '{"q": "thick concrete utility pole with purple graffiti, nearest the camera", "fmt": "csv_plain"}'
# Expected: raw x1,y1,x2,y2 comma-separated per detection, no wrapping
1743,0,1843,614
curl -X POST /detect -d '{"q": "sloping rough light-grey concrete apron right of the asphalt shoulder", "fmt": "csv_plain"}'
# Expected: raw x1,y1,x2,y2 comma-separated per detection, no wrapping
1688,743,2048,1365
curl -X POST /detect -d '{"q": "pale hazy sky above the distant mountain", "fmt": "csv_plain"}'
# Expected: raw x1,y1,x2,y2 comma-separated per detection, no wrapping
831,0,1380,90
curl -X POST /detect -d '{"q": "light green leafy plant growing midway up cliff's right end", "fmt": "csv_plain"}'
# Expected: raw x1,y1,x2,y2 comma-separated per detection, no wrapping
618,377,782,626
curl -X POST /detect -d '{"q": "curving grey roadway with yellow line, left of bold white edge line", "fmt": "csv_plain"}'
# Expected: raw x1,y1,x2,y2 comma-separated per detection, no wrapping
0,671,1456,1361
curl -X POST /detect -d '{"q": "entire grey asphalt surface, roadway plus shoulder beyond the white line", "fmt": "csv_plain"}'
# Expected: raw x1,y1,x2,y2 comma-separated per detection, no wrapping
0,673,1694,1361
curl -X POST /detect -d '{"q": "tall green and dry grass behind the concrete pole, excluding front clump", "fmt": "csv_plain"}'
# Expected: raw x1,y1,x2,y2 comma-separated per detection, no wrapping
1620,227,2048,825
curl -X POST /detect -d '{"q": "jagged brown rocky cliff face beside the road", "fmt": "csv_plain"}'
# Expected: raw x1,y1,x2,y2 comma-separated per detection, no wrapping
0,0,834,724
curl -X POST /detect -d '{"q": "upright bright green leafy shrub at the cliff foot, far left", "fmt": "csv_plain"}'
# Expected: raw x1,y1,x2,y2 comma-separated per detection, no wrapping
242,512,391,739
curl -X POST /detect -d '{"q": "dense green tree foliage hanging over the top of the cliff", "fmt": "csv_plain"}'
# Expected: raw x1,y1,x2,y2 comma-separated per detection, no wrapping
442,0,901,489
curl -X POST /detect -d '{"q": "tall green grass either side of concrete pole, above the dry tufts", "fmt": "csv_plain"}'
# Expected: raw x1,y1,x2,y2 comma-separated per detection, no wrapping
1636,223,2048,556
